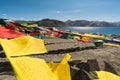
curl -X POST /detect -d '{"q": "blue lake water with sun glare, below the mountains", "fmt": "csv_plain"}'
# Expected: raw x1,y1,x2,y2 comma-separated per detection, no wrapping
57,27,120,35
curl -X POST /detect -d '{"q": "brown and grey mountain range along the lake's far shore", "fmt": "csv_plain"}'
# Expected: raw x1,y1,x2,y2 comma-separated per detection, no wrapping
13,19,120,27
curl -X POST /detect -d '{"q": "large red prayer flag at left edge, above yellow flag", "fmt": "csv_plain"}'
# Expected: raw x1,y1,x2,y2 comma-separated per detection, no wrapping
0,26,25,38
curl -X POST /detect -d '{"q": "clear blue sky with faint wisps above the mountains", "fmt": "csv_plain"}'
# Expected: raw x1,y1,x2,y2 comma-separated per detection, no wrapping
0,0,120,22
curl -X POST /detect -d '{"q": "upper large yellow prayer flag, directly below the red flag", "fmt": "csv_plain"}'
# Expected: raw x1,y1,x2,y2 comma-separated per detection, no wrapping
0,36,47,57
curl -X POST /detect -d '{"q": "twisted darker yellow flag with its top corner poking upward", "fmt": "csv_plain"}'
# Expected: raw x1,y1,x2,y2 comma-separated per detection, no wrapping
48,54,71,80
